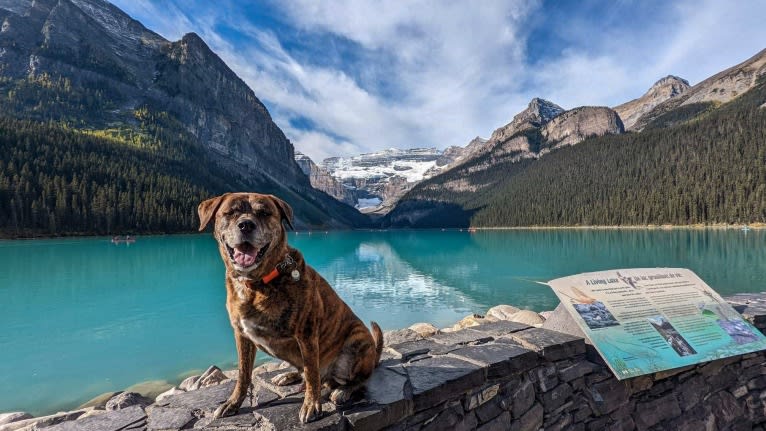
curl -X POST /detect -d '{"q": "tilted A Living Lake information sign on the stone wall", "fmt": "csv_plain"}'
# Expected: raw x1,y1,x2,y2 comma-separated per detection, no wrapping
547,268,766,380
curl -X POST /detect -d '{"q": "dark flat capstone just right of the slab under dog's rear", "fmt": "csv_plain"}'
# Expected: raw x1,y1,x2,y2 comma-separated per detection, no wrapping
404,356,485,411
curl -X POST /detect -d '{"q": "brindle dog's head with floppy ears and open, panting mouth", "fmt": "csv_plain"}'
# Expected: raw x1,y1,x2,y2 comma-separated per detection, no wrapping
197,193,293,277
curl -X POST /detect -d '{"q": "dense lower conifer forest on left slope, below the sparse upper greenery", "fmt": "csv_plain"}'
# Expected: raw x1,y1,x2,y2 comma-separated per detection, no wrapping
0,109,366,237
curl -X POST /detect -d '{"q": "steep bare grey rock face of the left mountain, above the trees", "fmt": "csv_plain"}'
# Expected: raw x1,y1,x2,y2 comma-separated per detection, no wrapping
0,0,364,230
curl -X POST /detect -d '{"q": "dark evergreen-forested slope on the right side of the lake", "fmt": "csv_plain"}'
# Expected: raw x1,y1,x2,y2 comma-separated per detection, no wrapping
384,79,766,227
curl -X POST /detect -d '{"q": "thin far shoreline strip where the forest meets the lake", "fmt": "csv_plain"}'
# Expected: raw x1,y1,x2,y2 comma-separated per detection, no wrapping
0,222,766,241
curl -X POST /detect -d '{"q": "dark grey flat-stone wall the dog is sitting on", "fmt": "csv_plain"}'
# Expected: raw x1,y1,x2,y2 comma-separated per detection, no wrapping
6,293,766,431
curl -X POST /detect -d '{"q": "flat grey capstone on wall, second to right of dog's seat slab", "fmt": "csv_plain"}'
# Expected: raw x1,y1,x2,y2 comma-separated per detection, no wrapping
450,343,537,379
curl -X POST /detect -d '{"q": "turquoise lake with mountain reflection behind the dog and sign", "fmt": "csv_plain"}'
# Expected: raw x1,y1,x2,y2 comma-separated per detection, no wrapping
0,229,766,414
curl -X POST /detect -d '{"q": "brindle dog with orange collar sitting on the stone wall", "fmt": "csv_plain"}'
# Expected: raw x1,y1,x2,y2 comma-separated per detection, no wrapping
198,193,383,423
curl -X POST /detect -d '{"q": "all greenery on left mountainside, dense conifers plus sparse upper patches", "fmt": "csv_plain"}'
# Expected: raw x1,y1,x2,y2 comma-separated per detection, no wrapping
0,74,367,237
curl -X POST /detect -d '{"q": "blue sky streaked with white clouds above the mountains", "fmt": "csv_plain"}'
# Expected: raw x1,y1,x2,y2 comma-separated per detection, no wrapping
114,0,766,162
